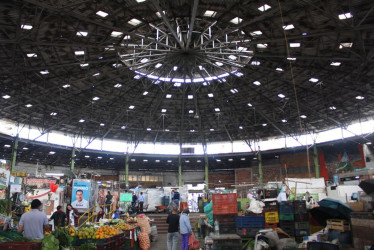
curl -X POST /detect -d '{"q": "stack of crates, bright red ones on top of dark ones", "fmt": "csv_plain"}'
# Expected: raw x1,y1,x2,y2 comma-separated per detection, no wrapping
212,193,238,234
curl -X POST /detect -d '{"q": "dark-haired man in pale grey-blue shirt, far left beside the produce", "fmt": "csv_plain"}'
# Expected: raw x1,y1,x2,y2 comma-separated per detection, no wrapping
17,199,48,240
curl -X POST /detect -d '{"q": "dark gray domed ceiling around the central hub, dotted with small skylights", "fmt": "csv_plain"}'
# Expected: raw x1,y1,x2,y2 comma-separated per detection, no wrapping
0,0,374,143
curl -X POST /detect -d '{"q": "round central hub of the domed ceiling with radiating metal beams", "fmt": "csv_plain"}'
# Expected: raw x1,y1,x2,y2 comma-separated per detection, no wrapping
119,18,253,83
